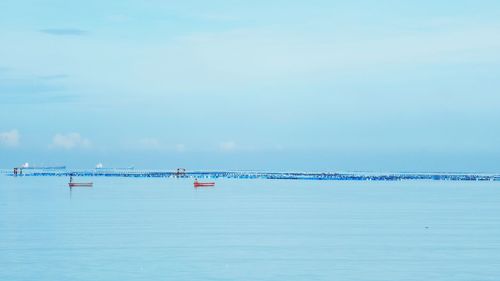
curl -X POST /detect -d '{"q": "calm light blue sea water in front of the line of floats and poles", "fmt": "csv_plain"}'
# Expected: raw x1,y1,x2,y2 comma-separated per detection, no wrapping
0,175,500,281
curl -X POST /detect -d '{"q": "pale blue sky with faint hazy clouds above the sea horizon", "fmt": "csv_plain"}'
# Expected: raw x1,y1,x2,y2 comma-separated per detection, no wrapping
0,0,500,172
